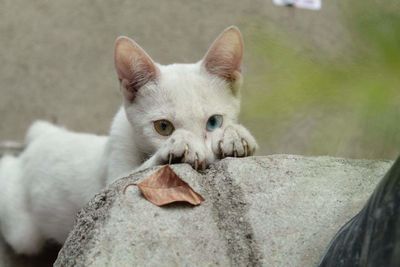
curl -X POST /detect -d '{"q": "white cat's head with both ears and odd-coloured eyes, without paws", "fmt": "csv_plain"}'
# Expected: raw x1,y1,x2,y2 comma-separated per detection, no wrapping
115,27,243,157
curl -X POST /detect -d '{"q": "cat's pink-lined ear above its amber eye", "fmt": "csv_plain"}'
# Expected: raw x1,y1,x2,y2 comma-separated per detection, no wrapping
114,36,159,102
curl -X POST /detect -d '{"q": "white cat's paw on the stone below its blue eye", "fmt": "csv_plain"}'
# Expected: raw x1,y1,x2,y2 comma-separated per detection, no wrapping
212,124,258,159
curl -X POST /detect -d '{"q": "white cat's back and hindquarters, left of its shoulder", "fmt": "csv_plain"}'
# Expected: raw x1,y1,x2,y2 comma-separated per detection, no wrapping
0,121,108,254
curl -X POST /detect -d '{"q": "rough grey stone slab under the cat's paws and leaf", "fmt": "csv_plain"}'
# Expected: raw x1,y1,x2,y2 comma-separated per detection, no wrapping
55,155,392,266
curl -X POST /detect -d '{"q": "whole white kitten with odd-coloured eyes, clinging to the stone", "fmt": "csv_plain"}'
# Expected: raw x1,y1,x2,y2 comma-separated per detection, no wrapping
0,27,257,254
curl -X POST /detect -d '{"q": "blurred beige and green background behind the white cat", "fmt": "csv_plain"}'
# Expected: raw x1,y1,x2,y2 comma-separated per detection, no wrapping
0,0,400,159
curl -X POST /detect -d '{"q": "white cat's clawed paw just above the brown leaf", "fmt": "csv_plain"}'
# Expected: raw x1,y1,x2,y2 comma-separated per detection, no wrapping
157,130,207,170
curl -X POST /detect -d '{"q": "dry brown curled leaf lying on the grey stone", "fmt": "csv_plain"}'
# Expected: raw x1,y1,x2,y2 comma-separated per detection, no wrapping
137,165,204,206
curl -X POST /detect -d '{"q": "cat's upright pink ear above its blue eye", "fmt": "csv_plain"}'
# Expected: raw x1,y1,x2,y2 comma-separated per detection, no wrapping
202,26,243,94
